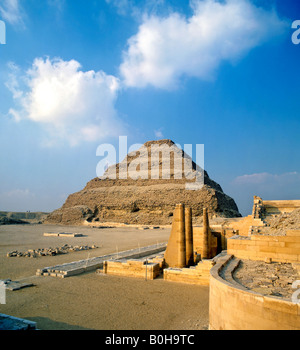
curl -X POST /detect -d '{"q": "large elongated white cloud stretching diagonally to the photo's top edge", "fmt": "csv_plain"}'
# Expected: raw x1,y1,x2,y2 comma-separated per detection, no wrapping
120,0,288,89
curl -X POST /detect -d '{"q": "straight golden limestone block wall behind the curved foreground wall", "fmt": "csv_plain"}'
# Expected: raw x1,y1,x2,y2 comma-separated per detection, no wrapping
227,230,300,263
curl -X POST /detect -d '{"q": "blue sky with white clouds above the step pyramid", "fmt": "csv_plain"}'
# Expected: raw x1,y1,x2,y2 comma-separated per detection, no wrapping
0,0,300,215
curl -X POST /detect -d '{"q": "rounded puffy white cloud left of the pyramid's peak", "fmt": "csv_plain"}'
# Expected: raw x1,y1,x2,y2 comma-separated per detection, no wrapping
7,58,122,145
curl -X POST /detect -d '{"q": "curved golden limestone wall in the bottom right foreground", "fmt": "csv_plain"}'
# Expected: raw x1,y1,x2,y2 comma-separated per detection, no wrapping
209,256,300,330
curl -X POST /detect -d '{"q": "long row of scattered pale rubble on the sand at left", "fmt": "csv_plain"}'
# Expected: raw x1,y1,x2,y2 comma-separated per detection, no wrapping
6,244,98,258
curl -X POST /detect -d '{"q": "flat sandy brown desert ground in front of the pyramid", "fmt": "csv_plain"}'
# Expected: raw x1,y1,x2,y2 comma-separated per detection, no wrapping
0,225,209,330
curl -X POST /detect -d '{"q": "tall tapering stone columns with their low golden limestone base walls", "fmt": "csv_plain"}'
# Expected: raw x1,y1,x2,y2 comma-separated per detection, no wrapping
99,204,223,285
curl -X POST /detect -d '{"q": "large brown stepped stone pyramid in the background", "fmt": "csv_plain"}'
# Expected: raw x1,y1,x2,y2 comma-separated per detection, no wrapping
45,140,241,226
